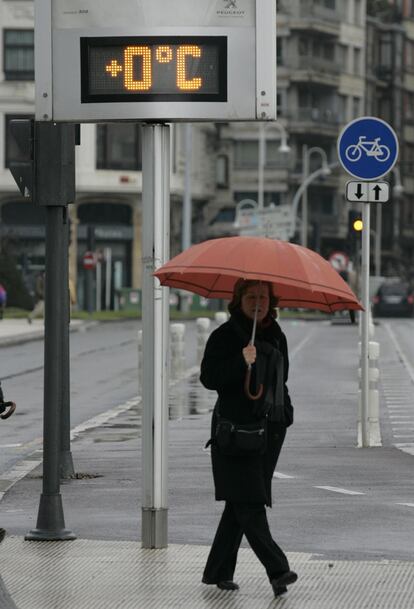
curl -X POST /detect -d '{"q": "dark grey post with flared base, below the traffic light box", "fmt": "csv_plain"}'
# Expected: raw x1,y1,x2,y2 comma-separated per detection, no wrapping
25,206,76,541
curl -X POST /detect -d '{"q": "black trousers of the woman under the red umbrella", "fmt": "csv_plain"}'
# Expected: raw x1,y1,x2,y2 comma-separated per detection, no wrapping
202,501,289,584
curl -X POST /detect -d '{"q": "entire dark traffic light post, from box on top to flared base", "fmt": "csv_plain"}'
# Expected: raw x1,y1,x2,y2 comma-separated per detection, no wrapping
25,123,75,541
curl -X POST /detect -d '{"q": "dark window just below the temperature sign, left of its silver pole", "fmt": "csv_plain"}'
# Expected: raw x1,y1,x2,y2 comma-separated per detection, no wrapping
96,123,142,171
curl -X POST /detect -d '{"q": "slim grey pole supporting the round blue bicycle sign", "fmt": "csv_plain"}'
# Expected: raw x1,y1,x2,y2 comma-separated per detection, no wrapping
361,203,371,448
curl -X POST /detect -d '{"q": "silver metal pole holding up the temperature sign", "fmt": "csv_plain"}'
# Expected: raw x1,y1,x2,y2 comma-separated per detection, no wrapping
142,124,170,548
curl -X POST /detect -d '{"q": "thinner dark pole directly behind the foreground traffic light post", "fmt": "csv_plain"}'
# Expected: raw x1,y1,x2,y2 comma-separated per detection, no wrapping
60,207,75,478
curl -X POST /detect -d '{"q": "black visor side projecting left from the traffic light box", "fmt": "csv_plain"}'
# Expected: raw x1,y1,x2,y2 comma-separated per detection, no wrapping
9,118,34,197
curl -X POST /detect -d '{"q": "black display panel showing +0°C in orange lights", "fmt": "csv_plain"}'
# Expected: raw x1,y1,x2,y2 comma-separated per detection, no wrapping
81,36,227,103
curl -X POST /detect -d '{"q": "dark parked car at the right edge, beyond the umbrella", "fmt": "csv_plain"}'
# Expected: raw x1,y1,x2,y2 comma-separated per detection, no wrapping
372,281,414,317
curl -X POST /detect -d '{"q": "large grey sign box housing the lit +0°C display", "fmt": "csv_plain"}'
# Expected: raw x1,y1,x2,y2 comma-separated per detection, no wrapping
35,0,276,122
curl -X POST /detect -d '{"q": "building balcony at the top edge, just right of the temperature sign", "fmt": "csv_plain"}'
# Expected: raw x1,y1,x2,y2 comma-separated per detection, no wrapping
280,0,341,37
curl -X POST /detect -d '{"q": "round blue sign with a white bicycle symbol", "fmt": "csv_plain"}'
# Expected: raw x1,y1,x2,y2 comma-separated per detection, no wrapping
338,116,398,180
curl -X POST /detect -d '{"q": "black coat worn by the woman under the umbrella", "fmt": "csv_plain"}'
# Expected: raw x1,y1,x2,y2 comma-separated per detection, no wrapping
200,316,293,506
